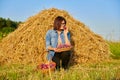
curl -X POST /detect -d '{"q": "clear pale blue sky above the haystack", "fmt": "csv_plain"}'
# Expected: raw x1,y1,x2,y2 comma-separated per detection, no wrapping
0,0,120,41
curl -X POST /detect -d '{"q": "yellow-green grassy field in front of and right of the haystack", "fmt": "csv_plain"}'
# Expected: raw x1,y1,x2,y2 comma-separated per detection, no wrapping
0,42,120,80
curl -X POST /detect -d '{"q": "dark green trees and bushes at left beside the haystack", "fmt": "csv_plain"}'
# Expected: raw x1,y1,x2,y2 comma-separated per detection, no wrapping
0,17,22,39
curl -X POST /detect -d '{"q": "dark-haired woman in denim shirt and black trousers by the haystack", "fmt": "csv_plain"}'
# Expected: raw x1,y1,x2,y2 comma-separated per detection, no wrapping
46,16,71,69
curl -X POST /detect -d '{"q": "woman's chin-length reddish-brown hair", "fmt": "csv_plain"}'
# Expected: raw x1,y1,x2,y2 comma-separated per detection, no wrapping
53,16,66,30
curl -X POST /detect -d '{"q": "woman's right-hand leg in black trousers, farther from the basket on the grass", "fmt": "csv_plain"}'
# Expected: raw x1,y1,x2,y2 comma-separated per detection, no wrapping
61,51,71,69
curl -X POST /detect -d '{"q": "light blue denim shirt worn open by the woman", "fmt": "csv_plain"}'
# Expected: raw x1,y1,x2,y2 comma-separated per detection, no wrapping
46,29,70,61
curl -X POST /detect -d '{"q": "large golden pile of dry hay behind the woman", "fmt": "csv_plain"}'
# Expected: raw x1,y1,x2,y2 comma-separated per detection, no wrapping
0,8,110,64
